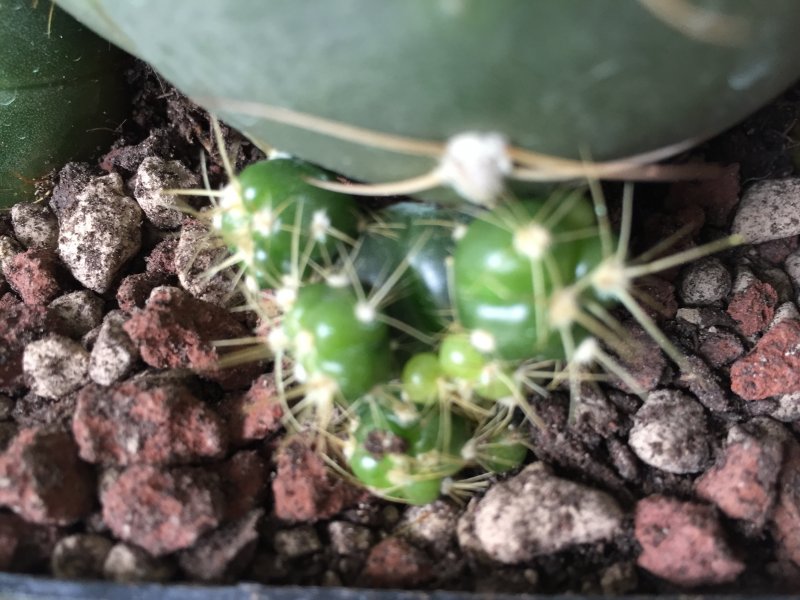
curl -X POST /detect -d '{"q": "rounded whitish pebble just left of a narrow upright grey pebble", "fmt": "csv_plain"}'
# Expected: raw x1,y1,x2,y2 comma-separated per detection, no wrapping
22,335,89,399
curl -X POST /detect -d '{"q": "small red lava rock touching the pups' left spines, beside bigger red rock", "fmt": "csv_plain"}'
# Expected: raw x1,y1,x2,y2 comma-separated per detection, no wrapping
223,374,283,445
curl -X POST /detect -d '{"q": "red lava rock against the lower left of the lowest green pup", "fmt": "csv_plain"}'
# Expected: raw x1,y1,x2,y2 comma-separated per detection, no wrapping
272,436,358,522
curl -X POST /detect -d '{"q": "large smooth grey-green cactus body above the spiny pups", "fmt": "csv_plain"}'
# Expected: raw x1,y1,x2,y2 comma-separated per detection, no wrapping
53,0,800,200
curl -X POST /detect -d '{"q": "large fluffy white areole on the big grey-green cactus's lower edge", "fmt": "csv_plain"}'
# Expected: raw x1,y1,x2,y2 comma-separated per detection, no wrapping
439,131,513,205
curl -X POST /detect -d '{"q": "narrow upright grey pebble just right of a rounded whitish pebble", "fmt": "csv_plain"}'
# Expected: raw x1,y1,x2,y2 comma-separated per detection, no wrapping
89,310,139,385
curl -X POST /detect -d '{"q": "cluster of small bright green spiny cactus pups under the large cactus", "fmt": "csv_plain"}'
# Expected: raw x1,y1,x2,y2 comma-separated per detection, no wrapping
181,120,737,504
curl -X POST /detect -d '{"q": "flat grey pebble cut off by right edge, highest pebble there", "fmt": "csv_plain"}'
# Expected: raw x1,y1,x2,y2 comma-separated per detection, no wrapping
732,178,800,244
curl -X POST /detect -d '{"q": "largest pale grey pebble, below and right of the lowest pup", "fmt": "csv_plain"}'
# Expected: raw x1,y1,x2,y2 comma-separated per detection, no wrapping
459,463,624,564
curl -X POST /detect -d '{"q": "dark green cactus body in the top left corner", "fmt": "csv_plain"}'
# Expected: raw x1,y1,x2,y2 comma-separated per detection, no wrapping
0,0,125,208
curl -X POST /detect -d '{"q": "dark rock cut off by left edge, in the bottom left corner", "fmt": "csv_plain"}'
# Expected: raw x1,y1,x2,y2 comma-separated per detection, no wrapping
0,513,58,571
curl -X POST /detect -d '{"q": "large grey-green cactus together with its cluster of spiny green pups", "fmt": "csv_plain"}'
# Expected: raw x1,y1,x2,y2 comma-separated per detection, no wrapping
42,0,780,503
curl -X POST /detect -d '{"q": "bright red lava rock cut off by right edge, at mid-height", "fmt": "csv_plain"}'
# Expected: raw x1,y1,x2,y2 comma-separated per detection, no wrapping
731,320,800,400
